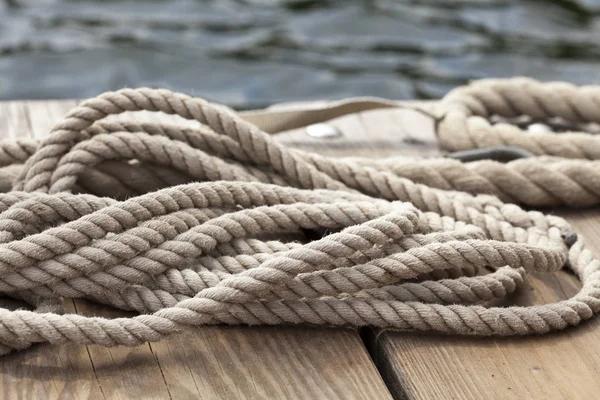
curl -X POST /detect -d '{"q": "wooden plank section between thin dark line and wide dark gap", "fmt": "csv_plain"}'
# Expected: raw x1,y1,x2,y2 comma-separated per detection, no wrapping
152,327,389,399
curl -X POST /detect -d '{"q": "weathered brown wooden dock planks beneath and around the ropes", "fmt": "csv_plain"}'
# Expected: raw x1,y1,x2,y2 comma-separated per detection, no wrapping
0,101,600,399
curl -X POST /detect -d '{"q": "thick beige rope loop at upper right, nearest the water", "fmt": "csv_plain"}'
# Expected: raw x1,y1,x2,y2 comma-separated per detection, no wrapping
437,78,600,160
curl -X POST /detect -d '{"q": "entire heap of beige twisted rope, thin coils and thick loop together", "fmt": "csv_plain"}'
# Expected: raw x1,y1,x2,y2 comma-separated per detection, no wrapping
0,79,600,353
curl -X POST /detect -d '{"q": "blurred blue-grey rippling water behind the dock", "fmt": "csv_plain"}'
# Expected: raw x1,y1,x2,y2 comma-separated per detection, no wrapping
0,0,600,108
